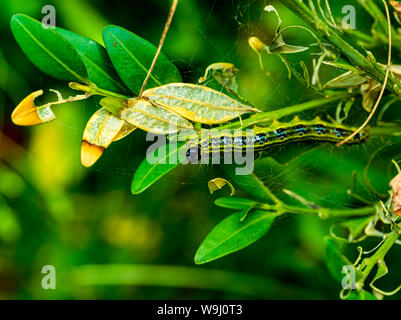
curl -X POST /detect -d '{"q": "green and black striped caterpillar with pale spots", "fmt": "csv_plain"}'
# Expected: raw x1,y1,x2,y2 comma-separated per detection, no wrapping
186,117,369,158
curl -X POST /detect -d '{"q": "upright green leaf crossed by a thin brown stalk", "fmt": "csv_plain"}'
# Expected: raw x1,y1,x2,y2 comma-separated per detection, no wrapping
103,26,182,94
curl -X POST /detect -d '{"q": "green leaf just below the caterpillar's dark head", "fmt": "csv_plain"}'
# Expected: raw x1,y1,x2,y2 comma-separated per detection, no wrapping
131,142,186,194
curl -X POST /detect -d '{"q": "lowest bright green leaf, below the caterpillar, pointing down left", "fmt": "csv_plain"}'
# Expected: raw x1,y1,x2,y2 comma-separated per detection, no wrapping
195,210,278,264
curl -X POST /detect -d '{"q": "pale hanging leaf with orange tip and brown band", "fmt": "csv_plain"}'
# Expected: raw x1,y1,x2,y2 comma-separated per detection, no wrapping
81,107,136,167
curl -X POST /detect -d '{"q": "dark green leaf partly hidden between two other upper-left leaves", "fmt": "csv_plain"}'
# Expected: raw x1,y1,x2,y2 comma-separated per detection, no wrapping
56,28,129,93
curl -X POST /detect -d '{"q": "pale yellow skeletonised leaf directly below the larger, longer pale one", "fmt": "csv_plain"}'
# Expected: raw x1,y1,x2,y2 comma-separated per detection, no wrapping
120,99,193,134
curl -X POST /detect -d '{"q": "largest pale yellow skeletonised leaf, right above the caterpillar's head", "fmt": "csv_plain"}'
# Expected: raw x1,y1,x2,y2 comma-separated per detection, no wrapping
143,83,259,124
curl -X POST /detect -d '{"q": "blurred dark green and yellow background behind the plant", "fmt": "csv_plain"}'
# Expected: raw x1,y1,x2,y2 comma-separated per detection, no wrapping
0,0,401,299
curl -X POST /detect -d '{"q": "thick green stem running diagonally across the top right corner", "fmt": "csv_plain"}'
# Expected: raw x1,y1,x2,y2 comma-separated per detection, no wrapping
280,0,401,97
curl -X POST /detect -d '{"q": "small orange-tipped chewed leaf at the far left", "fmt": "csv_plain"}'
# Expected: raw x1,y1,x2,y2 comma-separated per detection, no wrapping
11,90,56,126
